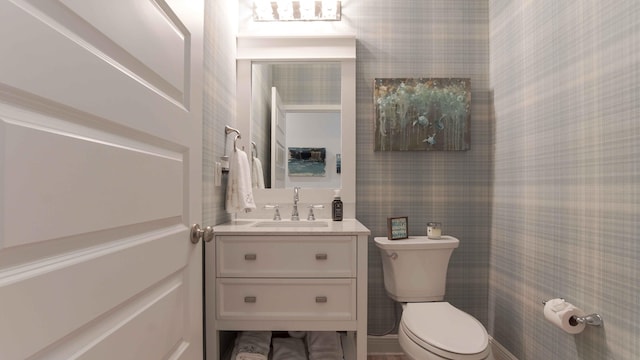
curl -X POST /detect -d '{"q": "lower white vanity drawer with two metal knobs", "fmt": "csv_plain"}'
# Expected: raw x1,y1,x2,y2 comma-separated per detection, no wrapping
216,278,356,320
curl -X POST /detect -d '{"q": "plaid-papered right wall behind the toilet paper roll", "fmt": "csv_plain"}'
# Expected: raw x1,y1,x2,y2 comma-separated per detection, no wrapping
490,0,640,360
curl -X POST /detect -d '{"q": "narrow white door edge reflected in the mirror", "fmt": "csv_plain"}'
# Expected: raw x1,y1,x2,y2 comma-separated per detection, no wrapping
271,86,288,189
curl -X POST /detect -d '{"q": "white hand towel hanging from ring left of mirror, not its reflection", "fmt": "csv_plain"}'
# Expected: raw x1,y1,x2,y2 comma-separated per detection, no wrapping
225,149,256,213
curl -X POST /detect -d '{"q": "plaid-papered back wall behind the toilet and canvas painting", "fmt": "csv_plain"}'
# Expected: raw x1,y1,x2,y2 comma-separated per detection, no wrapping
352,0,492,334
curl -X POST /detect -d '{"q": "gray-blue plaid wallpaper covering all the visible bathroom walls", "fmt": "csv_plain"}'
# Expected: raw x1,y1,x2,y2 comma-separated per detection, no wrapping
204,0,640,360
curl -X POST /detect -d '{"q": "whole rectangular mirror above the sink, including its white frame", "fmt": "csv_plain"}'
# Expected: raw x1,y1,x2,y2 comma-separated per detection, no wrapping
235,35,356,218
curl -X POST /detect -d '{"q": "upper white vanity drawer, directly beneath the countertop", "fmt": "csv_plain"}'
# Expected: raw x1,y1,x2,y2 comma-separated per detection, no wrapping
216,236,356,278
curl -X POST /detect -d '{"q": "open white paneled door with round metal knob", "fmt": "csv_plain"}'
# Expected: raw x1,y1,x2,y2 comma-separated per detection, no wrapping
0,0,204,360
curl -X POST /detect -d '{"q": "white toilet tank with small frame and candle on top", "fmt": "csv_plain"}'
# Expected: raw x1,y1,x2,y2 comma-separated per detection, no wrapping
374,236,460,302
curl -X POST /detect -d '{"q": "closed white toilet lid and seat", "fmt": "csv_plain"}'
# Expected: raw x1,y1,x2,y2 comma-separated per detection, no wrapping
400,302,490,360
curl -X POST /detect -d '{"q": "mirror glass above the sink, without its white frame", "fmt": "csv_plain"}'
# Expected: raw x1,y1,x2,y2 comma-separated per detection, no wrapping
250,61,342,189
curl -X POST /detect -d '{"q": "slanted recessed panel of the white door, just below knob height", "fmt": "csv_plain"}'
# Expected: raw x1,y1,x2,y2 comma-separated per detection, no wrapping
0,227,187,359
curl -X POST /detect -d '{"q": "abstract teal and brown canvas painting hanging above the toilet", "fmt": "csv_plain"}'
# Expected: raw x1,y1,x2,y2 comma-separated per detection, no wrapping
374,78,471,151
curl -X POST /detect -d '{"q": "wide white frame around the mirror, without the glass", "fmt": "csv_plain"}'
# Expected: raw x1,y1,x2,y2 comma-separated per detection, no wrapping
236,35,356,219
